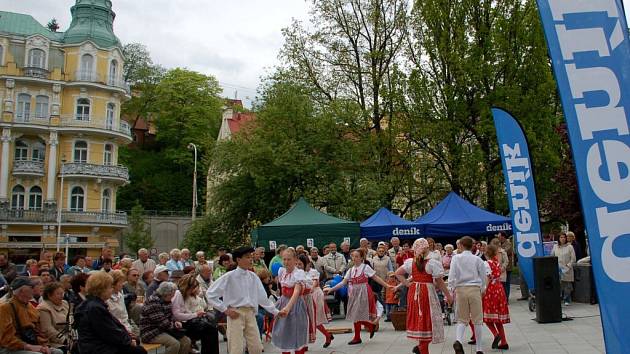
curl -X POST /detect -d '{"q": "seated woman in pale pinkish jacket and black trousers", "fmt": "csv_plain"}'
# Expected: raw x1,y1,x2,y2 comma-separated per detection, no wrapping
172,273,219,354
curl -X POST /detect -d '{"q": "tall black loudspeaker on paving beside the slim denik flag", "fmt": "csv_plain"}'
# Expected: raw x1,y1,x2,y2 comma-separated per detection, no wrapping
534,256,562,323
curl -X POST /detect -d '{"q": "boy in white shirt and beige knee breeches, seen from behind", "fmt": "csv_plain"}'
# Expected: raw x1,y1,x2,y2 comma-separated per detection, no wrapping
448,236,486,354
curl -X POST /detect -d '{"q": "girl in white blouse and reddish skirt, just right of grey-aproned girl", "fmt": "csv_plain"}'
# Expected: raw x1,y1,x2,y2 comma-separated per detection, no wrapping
297,254,335,348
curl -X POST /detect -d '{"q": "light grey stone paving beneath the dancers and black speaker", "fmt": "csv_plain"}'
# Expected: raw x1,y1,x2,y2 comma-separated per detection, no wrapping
221,286,604,354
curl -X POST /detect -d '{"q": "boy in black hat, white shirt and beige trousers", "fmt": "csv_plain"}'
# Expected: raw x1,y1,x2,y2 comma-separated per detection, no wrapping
206,247,279,354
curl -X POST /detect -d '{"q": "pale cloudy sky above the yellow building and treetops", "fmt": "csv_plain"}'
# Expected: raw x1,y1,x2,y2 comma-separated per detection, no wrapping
0,0,309,105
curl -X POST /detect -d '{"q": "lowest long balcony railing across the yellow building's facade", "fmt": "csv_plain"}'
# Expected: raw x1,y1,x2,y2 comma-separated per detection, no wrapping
0,209,127,226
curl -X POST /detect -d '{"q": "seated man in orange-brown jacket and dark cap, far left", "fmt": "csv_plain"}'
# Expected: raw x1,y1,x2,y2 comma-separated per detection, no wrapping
0,277,63,354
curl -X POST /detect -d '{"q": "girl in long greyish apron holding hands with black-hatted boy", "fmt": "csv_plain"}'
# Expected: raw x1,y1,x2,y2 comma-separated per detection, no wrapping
271,248,308,354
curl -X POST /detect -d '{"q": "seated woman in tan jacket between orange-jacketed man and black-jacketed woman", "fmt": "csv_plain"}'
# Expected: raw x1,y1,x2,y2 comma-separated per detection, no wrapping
37,282,70,349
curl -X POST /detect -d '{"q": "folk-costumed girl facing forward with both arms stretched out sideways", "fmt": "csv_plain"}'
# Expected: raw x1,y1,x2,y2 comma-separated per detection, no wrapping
324,249,390,345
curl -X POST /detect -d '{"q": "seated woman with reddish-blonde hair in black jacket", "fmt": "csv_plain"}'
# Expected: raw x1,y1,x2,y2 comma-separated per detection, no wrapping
73,272,147,354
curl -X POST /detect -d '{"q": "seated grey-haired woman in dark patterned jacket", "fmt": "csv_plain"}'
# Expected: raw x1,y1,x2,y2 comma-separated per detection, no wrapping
140,281,191,354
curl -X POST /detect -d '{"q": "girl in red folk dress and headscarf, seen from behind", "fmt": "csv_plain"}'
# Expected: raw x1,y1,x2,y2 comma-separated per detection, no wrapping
396,238,453,354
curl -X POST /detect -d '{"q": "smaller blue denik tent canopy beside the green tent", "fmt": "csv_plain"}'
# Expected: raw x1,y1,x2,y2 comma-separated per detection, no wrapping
361,208,420,239
